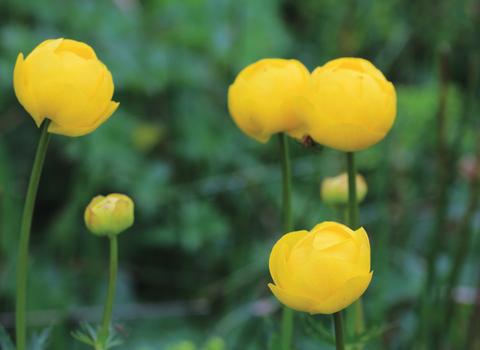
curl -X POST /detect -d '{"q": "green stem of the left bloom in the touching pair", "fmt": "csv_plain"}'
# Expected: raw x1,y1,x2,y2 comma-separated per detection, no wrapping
278,133,293,350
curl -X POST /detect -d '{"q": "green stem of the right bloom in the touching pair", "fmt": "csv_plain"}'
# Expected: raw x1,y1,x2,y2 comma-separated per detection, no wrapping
347,152,365,349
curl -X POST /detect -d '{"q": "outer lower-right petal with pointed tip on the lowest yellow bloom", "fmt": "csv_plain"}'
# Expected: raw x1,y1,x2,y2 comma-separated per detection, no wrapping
310,272,373,315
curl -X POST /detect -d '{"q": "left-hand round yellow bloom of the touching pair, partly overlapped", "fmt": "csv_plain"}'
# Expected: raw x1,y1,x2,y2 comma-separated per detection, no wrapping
228,58,310,143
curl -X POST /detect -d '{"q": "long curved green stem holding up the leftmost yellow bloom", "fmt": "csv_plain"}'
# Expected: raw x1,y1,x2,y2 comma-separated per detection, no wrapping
15,119,50,350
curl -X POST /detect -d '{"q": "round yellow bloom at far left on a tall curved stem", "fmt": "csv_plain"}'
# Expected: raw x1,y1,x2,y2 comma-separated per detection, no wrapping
13,39,118,136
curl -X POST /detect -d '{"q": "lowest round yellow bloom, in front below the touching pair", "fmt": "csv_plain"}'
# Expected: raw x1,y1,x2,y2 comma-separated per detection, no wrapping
268,222,373,315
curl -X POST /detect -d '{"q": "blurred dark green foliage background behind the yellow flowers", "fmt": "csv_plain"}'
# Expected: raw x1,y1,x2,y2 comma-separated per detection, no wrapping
0,0,480,350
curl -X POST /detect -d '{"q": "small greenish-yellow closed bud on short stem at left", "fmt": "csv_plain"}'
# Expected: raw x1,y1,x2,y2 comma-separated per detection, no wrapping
85,193,133,237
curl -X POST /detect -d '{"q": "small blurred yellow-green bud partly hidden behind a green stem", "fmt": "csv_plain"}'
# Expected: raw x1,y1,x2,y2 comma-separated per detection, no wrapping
320,172,367,207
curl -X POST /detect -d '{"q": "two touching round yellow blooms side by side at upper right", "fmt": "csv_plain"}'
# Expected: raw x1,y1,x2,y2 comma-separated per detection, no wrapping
228,58,397,152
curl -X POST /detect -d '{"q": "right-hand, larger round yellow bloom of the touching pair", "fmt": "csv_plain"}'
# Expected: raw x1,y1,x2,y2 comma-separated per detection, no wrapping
289,58,397,152
